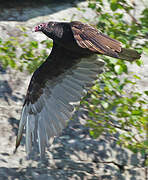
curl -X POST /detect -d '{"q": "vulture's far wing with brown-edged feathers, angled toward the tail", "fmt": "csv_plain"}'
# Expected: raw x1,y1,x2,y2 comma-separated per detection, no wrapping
70,21,122,58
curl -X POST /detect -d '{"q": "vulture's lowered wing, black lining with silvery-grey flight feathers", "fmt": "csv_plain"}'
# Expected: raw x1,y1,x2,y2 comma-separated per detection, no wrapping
16,44,104,155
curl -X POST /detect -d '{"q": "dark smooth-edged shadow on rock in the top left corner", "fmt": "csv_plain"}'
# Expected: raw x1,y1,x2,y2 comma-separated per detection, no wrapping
0,0,84,21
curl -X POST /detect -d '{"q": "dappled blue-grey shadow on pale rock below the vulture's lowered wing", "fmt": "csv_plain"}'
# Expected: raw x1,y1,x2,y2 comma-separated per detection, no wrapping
4,109,145,180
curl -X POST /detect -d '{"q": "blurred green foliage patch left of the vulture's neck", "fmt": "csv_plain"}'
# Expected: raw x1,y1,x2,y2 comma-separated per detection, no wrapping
0,30,52,73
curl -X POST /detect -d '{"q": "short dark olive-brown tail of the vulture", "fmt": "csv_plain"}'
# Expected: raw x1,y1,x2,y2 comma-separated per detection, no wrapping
118,48,141,62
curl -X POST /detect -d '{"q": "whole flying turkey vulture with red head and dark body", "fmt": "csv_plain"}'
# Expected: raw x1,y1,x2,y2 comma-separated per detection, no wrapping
16,21,140,155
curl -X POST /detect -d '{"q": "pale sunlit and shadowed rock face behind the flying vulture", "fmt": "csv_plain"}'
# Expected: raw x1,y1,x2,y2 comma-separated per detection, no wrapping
0,1,148,180
